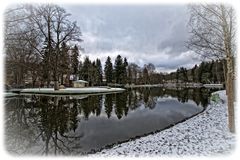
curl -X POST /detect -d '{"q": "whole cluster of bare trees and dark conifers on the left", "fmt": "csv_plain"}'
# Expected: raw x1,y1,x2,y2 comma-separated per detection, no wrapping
4,4,82,89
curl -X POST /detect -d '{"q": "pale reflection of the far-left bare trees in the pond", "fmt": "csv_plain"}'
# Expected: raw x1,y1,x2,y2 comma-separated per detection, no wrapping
5,98,38,154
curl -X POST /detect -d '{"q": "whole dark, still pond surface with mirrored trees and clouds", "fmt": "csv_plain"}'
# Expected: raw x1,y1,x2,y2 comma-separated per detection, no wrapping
5,88,217,155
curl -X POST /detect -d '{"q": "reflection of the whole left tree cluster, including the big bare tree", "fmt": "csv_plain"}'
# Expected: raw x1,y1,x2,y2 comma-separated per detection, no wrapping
6,96,83,154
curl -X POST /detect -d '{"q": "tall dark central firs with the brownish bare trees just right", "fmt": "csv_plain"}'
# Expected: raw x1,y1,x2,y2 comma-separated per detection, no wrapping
104,55,162,84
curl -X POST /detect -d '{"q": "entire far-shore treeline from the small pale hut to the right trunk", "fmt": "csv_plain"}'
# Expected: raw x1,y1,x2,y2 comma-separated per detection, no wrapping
79,55,225,85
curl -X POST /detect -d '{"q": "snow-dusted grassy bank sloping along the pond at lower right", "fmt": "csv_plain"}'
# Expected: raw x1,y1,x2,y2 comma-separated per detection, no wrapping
92,91,235,157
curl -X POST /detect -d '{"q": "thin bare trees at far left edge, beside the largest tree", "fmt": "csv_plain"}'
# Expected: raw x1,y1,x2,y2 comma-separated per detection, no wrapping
4,5,39,85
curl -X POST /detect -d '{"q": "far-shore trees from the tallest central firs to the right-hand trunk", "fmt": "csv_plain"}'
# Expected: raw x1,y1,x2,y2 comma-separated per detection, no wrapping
101,55,225,84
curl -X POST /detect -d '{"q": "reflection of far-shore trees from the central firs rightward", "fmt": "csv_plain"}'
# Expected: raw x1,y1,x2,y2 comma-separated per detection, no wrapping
104,88,211,119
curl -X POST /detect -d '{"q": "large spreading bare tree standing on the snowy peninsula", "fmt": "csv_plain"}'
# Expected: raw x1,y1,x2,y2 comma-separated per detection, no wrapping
31,5,82,90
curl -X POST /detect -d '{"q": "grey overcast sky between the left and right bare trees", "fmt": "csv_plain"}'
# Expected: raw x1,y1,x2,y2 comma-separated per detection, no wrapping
63,5,199,72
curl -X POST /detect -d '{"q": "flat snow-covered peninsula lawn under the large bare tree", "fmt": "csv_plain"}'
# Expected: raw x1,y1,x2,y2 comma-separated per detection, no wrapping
15,87,124,94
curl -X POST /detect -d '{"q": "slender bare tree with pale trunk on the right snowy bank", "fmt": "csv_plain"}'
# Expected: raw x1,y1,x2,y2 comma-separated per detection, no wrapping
188,4,236,132
